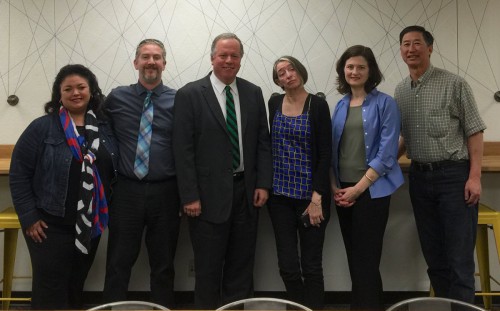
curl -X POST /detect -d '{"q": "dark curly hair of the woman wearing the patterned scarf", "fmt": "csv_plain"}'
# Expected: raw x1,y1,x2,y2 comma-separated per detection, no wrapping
44,64,104,118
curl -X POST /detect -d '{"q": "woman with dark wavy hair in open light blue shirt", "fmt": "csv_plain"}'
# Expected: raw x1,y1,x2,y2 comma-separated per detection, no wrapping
332,45,403,310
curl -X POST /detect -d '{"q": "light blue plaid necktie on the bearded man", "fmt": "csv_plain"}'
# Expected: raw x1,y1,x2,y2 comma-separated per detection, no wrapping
134,91,153,179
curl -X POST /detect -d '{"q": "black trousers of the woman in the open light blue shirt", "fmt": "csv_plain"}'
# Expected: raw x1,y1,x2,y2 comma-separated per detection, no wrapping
336,183,391,310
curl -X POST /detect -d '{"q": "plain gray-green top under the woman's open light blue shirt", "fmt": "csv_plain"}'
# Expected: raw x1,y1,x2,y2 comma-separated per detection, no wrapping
339,106,367,182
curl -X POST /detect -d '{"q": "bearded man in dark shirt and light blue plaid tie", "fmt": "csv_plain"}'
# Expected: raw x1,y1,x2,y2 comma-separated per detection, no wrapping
103,39,180,308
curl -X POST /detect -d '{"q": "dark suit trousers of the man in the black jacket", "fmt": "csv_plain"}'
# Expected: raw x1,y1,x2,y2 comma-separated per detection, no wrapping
189,179,258,310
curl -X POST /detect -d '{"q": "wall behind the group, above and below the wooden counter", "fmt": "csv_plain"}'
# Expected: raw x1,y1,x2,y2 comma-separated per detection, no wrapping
0,0,500,291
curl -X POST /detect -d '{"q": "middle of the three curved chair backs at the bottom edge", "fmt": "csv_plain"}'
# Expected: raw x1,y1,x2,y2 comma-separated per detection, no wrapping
216,297,312,311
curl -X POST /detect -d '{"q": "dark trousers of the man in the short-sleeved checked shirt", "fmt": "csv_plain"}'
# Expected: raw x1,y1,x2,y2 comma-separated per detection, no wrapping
409,162,478,303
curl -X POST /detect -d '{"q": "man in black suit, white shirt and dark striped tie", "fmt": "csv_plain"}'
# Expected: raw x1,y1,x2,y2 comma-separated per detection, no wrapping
173,33,272,309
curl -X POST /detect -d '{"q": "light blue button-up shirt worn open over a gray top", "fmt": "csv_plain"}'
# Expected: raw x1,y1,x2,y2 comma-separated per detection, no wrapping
332,89,404,198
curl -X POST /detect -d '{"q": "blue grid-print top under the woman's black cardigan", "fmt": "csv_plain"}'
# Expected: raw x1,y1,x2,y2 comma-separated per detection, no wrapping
272,111,312,200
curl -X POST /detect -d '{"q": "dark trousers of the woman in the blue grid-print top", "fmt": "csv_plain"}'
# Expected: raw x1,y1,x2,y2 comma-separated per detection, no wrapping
268,195,330,309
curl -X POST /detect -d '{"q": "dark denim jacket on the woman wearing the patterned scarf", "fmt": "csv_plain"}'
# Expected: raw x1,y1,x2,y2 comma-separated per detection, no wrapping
9,114,118,229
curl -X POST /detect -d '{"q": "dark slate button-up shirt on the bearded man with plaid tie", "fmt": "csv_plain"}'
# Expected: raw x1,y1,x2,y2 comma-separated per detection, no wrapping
104,83,176,182
